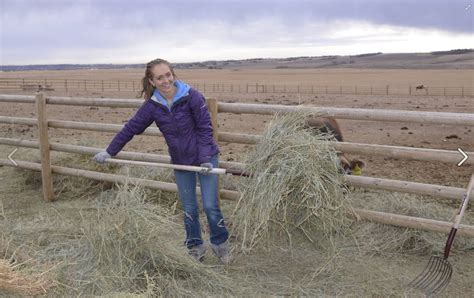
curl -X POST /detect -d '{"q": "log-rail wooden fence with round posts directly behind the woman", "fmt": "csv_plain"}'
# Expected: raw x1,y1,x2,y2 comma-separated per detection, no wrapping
0,93,474,237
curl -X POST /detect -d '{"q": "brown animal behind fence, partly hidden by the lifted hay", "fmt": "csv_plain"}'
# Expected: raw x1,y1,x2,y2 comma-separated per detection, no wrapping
307,117,365,175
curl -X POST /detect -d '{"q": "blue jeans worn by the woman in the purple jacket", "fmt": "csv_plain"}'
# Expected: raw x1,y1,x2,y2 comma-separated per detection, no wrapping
174,154,229,248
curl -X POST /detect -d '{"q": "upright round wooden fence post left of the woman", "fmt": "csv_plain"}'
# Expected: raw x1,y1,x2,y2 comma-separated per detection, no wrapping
35,93,54,202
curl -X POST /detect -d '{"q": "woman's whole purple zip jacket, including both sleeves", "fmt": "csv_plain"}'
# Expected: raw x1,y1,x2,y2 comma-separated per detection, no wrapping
107,88,219,165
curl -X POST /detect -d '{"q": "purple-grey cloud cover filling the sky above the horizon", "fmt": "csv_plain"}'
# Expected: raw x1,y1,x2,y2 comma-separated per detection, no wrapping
0,0,473,64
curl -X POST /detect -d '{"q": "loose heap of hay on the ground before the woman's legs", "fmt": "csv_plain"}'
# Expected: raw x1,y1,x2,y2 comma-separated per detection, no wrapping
39,182,230,295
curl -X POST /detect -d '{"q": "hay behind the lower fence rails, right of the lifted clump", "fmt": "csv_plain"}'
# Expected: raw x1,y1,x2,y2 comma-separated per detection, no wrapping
351,191,474,254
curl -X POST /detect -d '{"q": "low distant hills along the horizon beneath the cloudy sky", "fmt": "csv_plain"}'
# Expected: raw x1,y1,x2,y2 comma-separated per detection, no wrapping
0,49,474,71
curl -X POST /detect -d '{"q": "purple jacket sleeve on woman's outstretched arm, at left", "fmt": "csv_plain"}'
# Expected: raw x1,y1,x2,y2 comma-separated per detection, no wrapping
106,103,153,156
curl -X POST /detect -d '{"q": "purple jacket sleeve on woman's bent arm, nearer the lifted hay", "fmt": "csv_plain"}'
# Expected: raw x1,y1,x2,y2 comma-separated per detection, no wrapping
190,91,219,163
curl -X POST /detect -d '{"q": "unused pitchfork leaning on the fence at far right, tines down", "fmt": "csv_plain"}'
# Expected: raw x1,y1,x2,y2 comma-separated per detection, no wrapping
408,173,474,296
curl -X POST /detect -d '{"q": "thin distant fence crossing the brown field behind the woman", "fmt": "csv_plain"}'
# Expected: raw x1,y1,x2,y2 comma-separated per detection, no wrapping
0,78,474,97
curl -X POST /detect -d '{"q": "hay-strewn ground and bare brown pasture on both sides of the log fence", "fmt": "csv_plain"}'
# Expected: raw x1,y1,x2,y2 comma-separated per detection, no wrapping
0,69,474,297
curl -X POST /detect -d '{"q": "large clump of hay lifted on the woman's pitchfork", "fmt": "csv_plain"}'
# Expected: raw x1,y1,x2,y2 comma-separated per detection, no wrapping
233,113,351,252
